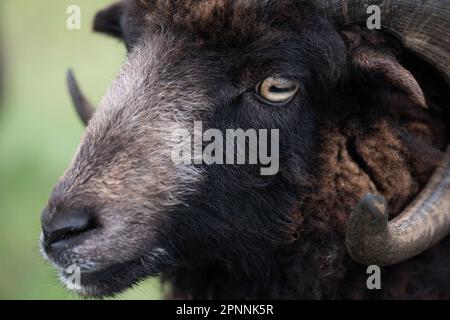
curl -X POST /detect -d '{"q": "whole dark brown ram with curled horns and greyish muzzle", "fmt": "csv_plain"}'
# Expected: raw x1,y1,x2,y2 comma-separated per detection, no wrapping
41,0,450,299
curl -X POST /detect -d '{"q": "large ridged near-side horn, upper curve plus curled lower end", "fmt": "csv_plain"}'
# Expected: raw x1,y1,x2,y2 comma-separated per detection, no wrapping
320,0,450,265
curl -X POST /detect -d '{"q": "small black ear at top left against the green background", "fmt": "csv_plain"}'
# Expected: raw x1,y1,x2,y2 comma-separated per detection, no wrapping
94,2,125,39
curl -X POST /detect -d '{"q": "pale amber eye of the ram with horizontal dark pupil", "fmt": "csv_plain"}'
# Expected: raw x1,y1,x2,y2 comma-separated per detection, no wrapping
256,77,299,103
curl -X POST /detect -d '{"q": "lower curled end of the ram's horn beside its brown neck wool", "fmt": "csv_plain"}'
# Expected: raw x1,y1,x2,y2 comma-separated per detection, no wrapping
346,146,450,266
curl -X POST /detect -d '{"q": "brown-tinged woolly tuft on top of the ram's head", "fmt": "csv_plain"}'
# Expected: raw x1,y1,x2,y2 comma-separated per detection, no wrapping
128,0,326,45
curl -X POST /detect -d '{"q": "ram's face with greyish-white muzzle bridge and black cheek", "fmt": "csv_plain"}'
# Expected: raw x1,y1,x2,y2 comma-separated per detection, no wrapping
42,0,346,296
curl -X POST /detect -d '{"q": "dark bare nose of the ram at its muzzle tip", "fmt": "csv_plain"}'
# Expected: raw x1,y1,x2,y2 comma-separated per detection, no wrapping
41,209,96,247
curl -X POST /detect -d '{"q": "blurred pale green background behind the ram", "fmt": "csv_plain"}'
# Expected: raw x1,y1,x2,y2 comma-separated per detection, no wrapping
0,0,160,299
